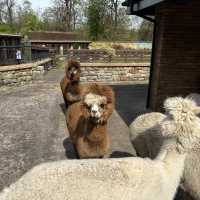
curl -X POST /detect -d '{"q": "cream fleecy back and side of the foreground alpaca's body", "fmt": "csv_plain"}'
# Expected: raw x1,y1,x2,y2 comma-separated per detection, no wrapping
0,157,183,200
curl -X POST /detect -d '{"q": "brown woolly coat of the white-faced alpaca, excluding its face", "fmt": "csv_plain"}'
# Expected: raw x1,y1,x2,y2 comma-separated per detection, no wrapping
66,84,115,158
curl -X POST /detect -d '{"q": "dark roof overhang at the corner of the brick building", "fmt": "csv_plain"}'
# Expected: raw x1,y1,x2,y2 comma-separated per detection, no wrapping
122,0,165,16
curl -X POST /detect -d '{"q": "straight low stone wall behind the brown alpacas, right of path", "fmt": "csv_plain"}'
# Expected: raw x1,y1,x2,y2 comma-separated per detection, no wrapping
81,63,150,83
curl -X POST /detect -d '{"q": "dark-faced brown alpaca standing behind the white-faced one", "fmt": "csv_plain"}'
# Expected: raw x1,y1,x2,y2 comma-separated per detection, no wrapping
60,60,81,107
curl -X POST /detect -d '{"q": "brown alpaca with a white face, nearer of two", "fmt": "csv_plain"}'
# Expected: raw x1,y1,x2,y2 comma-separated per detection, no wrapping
66,84,114,158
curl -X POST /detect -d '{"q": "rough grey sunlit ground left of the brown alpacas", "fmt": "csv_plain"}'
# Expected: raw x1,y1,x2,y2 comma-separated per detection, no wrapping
0,83,66,189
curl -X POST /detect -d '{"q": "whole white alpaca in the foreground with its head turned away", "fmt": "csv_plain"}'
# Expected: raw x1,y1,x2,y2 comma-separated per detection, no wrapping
0,98,200,200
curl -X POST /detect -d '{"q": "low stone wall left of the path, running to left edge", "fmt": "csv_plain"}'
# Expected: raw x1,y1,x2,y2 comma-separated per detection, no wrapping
0,58,52,87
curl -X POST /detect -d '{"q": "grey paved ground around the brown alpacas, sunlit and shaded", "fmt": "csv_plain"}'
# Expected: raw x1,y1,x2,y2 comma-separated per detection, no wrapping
0,70,146,190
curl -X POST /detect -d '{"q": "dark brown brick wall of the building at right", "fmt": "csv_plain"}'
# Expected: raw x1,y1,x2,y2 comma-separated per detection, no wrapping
149,0,200,111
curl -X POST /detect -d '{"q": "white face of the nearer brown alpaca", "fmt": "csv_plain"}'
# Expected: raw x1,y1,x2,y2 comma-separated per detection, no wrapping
84,93,107,122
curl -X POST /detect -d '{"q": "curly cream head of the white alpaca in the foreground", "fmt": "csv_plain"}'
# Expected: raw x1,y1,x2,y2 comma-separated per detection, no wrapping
161,97,200,152
